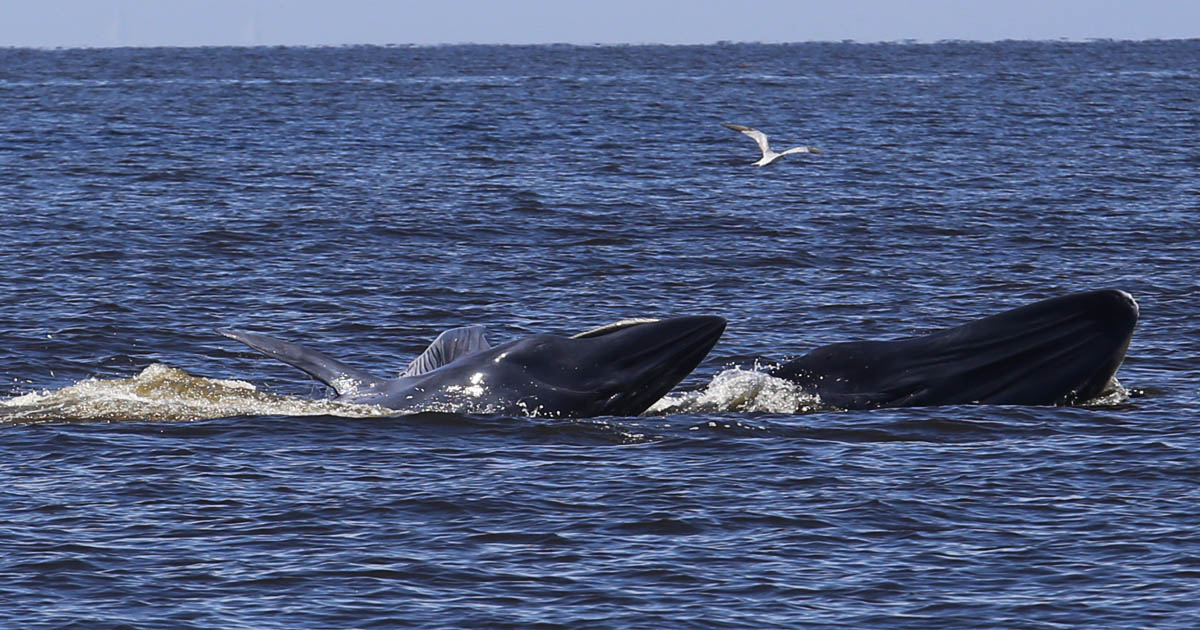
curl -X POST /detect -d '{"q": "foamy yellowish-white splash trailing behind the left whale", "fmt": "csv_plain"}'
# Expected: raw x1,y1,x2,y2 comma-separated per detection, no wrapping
0,364,396,426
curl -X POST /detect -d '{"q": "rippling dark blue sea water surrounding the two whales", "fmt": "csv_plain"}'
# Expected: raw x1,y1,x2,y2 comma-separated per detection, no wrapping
0,41,1200,629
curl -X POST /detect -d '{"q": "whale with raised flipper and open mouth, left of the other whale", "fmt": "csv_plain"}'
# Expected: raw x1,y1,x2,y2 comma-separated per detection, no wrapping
217,316,726,418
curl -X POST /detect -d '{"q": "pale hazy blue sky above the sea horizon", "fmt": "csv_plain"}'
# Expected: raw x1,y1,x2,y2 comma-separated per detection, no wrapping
0,0,1200,48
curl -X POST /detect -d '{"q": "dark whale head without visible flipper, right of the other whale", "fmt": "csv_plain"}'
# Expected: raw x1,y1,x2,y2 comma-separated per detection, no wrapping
769,289,1138,409
